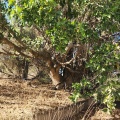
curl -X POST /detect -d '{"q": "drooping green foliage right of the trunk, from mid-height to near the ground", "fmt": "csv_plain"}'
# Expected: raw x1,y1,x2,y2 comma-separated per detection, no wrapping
70,43,120,112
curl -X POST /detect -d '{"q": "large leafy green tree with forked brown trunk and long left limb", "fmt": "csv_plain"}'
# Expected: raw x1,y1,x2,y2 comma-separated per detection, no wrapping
0,0,120,109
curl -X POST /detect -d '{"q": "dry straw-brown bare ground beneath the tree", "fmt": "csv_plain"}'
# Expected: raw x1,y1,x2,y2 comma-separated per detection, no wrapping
0,79,120,120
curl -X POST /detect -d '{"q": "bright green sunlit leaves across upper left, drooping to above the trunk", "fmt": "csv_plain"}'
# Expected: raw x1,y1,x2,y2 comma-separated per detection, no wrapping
5,0,91,51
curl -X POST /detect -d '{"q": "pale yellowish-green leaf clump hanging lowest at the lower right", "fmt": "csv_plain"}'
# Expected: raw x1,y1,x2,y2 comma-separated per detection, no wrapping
93,79,120,113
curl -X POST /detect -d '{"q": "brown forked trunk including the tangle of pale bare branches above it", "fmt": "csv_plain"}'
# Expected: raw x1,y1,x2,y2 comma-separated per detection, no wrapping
47,44,87,89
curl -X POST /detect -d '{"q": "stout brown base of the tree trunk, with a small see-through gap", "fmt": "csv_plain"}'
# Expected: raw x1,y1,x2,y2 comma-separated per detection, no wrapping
47,60,82,89
